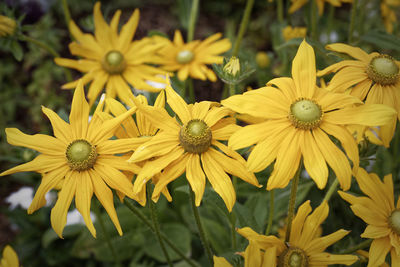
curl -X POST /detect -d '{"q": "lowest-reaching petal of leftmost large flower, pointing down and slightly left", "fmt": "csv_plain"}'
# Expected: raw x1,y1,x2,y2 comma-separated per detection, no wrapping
50,171,76,238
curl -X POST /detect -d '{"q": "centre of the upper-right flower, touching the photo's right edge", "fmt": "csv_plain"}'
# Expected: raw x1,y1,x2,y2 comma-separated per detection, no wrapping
367,55,399,85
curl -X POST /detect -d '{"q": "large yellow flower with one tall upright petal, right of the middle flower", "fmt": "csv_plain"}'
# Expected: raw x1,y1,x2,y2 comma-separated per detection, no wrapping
222,41,395,190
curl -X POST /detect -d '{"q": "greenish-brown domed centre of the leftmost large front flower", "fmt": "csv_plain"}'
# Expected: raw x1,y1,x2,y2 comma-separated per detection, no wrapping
65,139,97,171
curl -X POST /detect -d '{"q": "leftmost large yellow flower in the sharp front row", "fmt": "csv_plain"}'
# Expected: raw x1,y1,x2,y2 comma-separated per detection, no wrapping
0,82,140,238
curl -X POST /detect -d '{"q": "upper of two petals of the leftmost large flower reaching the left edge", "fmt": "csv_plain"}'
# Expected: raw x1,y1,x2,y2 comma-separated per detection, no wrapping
6,128,67,156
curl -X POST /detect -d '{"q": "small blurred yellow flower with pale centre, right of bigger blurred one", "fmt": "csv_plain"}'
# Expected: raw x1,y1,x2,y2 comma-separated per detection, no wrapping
159,30,231,82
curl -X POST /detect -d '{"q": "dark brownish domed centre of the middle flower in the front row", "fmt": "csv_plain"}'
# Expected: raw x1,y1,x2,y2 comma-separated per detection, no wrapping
179,119,212,154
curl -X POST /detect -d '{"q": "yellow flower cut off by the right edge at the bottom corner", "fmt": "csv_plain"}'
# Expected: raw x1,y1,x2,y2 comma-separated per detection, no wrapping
339,168,400,267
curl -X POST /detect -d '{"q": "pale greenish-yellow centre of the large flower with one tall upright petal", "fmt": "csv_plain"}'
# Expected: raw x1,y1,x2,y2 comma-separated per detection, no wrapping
289,98,323,130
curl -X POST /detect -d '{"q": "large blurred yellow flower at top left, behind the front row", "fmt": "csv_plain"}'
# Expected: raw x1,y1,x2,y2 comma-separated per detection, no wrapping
55,2,165,106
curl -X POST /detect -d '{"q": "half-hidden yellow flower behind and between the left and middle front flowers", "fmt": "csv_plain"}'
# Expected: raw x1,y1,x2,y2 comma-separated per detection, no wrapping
106,91,172,206
